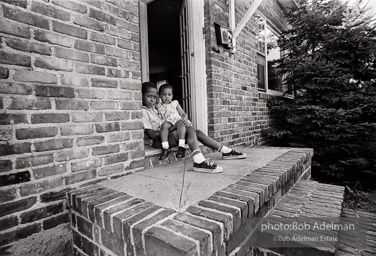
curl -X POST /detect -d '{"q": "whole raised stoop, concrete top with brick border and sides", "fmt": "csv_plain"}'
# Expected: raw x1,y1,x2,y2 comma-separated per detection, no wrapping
67,148,313,256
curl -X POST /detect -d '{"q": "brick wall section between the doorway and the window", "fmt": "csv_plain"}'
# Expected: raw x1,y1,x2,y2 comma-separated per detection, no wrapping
205,0,286,145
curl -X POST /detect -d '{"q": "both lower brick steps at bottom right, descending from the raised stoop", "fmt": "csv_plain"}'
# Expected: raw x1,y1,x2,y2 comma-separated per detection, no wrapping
239,180,376,256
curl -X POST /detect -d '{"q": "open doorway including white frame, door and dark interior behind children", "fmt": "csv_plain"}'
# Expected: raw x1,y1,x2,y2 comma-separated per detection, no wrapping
139,0,208,133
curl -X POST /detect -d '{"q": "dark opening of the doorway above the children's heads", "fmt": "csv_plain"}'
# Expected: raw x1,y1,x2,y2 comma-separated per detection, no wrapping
147,0,183,104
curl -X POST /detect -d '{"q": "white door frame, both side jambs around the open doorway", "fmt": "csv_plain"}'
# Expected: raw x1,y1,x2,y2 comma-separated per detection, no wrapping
139,0,208,134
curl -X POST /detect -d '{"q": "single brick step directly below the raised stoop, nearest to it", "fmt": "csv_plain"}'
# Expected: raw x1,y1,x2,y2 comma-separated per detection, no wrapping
238,180,344,256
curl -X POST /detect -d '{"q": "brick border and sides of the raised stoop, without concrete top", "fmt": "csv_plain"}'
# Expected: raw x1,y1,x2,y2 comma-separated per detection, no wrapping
67,149,313,256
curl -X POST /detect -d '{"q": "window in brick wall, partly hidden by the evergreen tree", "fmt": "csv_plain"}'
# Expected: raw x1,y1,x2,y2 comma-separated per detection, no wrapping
254,13,282,92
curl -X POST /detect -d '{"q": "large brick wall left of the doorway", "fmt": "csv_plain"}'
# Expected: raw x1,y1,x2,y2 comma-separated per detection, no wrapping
0,0,144,246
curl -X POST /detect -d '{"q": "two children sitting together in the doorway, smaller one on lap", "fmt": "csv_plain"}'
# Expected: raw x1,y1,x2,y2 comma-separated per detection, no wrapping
142,82,247,173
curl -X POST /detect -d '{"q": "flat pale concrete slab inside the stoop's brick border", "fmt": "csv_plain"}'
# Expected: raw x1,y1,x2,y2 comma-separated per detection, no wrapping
99,147,290,213
